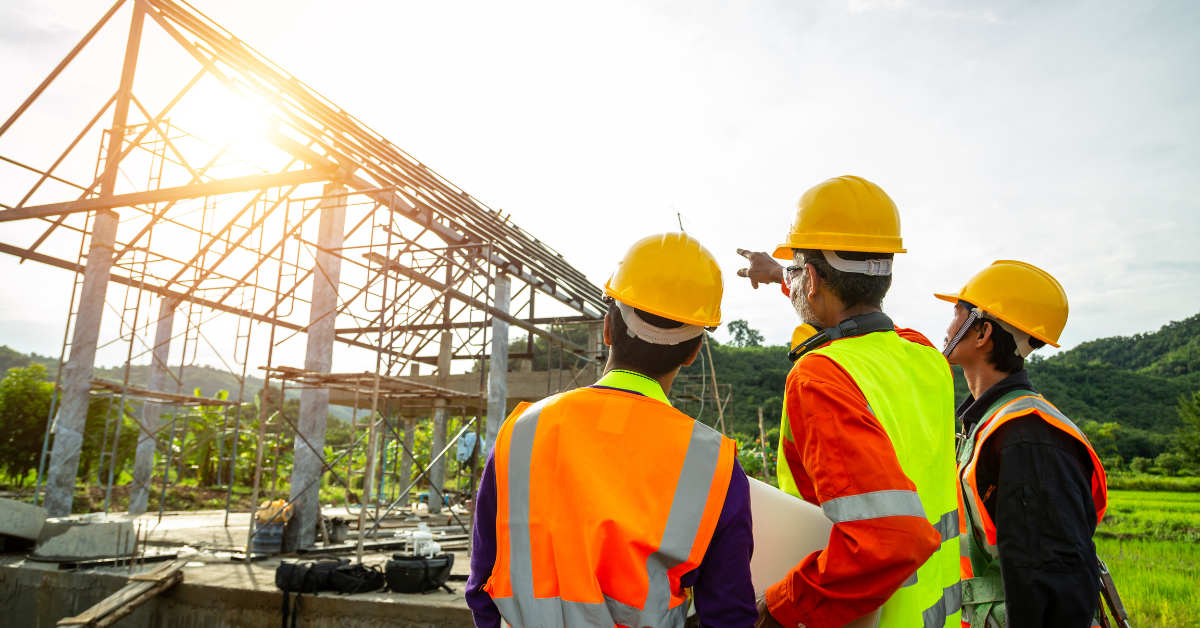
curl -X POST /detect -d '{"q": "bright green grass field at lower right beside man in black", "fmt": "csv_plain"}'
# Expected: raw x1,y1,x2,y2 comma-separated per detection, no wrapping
1096,491,1200,628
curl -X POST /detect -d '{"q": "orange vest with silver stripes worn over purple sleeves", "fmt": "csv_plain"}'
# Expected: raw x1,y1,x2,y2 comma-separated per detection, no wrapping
484,388,736,628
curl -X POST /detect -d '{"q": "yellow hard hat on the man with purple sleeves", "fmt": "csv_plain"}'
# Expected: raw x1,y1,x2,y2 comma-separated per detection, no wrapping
604,233,725,327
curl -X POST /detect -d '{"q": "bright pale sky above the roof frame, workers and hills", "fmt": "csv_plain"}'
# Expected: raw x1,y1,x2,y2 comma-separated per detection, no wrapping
0,0,1200,365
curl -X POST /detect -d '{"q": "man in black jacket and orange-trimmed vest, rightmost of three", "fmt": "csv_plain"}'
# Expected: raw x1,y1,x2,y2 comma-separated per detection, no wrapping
936,261,1108,628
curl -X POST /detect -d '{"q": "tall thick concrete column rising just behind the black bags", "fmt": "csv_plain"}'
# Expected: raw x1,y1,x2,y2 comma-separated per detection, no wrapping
283,184,346,551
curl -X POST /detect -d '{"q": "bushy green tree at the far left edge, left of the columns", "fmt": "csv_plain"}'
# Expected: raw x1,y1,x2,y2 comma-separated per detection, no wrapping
0,364,54,484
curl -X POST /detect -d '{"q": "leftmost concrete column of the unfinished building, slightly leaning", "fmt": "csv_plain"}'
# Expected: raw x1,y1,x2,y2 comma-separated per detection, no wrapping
43,210,118,516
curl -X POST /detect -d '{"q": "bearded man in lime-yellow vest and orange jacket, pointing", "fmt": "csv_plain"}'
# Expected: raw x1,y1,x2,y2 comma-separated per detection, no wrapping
738,177,960,628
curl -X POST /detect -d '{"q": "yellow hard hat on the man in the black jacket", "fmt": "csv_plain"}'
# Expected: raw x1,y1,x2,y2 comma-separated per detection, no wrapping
934,259,1068,347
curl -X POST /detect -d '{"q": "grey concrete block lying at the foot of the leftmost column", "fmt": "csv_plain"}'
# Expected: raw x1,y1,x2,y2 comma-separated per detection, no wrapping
34,518,137,561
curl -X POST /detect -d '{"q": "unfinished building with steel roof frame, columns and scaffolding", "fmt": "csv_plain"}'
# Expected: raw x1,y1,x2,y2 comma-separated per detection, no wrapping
0,0,667,626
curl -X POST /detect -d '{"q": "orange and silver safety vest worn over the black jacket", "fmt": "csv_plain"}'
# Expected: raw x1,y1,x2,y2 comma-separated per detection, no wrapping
958,391,1109,628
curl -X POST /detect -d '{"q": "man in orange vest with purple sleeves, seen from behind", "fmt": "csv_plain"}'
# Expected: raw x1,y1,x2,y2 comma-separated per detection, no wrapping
466,233,757,628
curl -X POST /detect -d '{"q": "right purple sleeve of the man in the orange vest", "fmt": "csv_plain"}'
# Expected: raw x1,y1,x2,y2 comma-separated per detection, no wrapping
679,461,758,628
